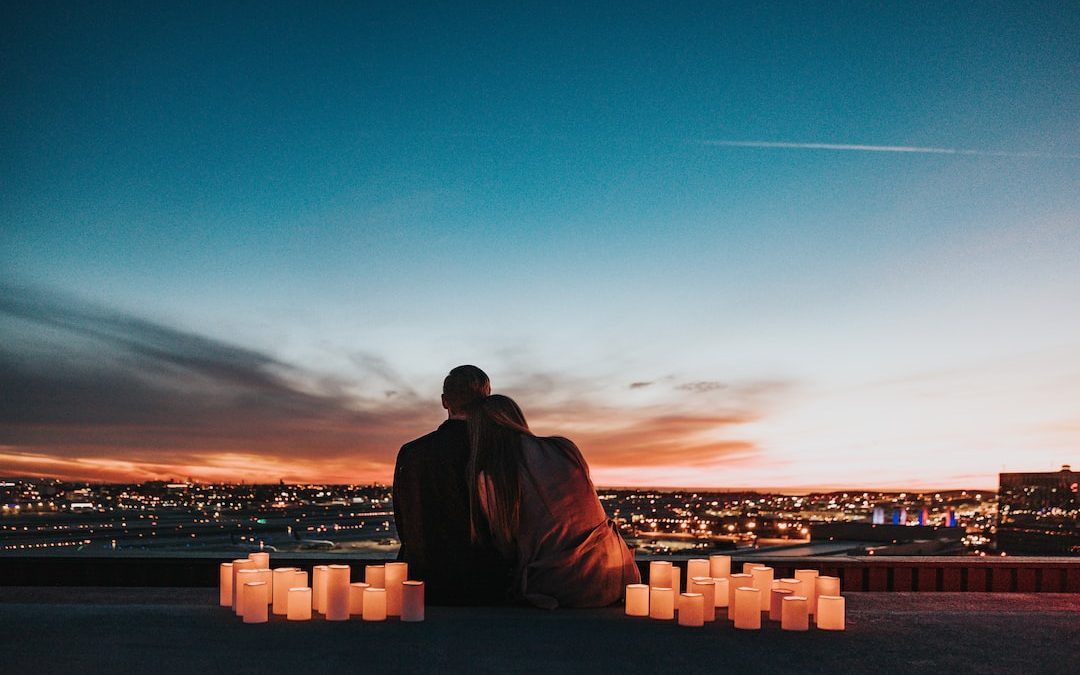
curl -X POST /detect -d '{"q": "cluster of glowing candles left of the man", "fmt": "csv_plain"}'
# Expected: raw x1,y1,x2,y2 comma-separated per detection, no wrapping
218,553,424,623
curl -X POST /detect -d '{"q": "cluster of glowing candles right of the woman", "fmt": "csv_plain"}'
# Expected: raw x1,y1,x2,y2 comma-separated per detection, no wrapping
626,555,846,631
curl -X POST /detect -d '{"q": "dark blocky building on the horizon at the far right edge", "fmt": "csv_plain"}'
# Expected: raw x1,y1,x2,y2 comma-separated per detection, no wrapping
997,464,1080,554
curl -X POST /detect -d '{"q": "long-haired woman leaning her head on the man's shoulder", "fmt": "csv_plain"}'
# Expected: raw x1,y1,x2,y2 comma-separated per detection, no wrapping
469,395,640,609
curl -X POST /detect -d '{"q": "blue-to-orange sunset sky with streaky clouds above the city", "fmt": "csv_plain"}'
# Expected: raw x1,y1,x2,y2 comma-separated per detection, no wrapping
0,1,1080,489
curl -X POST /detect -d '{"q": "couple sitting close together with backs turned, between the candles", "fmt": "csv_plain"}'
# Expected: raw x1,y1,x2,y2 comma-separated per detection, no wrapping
393,365,640,609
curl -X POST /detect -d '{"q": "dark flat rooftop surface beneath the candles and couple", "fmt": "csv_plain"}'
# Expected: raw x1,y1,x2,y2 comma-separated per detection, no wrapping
0,586,1080,675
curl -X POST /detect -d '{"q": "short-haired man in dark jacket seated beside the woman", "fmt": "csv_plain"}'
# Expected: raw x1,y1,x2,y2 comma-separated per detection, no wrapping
393,365,510,605
